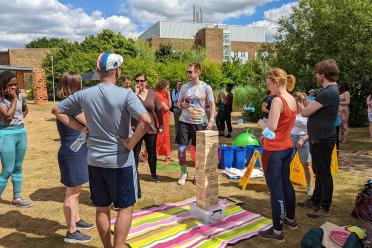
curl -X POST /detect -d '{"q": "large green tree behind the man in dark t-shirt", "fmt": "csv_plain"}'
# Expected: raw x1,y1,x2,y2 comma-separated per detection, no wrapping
276,0,372,126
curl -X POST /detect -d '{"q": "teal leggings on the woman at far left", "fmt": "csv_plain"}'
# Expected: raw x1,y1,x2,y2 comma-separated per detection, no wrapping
0,126,27,197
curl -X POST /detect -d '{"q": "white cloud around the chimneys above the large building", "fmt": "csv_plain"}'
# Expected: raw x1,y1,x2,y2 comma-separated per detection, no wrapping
123,0,274,26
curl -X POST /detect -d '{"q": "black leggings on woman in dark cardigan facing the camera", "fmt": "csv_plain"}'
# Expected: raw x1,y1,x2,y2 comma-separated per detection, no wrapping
133,134,157,175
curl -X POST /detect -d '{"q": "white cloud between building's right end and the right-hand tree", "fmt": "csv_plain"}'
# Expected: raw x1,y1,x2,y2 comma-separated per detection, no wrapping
248,2,298,42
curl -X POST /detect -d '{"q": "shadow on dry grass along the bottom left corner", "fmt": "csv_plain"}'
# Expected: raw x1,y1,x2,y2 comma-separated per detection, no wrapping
0,233,90,248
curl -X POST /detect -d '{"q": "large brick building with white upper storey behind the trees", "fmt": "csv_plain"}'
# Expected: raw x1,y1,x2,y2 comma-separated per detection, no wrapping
138,21,265,63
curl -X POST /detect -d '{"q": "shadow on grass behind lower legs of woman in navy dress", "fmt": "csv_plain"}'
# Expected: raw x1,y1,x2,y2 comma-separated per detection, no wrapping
30,186,92,206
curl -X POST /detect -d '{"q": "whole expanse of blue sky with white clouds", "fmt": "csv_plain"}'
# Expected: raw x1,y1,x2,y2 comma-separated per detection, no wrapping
0,0,297,50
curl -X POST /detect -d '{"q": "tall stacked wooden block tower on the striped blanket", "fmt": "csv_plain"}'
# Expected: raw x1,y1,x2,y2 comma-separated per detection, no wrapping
196,130,218,210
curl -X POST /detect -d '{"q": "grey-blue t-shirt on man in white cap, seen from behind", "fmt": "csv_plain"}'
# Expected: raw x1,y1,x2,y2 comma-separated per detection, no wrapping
58,83,147,168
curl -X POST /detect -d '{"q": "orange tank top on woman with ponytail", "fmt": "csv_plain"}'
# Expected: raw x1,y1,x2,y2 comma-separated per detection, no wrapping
263,96,296,151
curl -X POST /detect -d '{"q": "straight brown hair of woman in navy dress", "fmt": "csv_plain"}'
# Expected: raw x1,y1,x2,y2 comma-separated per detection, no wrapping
57,72,83,99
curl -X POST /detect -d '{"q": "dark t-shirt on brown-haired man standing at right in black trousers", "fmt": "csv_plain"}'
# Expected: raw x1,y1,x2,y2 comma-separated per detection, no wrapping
307,84,340,142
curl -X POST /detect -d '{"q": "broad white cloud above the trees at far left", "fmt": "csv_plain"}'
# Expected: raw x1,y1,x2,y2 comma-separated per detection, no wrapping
0,0,138,49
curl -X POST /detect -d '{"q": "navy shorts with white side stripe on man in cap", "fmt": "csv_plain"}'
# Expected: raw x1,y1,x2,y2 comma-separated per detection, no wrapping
88,165,141,208
